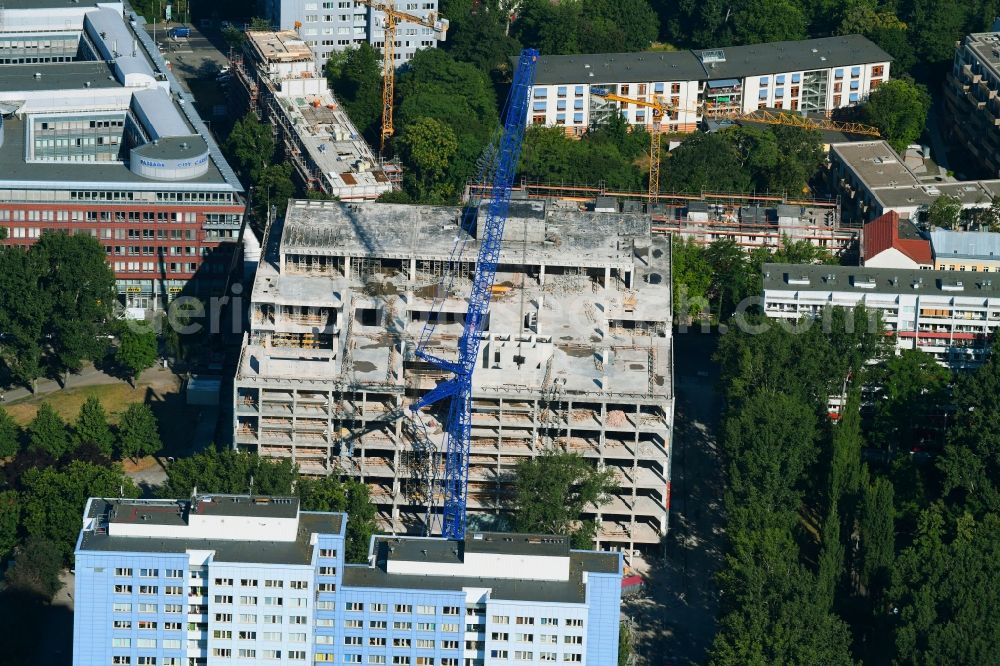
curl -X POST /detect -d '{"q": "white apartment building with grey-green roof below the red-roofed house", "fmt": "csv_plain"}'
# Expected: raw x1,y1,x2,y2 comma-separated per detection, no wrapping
764,264,1000,368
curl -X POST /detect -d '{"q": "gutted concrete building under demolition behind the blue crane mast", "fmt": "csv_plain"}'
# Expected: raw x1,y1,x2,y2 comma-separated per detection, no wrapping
233,200,674,559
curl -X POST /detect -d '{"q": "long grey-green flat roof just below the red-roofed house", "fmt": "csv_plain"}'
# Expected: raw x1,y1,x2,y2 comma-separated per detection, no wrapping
764,264,1000,298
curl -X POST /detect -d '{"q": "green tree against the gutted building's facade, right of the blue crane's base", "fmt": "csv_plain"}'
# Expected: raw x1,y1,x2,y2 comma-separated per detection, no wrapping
513,451,615,548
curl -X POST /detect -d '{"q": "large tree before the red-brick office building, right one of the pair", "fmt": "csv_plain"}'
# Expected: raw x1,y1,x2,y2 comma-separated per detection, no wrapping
28,231,117,374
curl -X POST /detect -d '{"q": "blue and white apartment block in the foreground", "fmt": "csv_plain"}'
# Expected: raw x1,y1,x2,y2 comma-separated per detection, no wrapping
73,495,622,666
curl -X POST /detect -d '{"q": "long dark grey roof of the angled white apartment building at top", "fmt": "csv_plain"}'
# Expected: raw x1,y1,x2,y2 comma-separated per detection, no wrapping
535,35,892,85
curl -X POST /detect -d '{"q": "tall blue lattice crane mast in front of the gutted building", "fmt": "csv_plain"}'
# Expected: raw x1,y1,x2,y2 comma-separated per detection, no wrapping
410,49,538,539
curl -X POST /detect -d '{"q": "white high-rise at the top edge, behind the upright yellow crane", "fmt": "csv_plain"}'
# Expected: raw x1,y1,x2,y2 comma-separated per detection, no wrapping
264,0,447,68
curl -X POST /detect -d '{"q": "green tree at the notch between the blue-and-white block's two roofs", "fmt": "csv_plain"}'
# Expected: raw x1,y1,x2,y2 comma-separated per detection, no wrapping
295,476,378,562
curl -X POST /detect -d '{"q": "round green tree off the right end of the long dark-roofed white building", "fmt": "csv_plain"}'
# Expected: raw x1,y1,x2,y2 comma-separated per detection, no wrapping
861,78,928,152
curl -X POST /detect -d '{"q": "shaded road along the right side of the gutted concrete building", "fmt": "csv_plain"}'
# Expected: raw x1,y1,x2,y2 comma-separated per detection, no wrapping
625,332,724,666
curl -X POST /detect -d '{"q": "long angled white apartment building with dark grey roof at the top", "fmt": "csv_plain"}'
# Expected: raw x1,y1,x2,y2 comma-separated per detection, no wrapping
529,35,892,135
